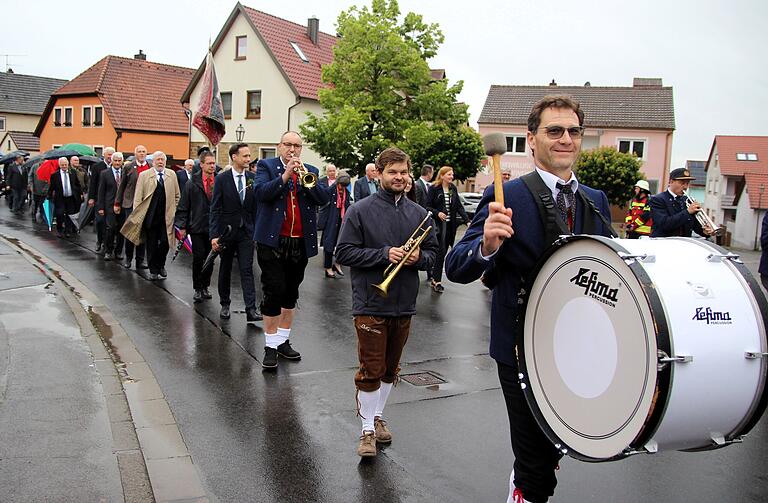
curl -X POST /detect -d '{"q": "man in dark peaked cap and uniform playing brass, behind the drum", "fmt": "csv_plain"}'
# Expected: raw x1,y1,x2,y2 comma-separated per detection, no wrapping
650,168,714,238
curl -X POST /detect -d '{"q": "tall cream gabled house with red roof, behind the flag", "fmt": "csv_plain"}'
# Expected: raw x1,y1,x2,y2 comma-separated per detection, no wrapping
181,3,337,166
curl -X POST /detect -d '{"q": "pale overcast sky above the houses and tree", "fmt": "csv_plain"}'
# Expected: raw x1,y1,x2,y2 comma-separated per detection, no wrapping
0,0,768,168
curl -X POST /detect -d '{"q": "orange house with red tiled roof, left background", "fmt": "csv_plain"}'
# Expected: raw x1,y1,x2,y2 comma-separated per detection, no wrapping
35,51,194,160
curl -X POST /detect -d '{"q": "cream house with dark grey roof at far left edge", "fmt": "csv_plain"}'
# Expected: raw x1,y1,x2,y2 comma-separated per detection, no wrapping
0,70,67,154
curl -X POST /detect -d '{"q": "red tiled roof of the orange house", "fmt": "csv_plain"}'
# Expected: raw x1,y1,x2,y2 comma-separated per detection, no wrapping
52,56,195,134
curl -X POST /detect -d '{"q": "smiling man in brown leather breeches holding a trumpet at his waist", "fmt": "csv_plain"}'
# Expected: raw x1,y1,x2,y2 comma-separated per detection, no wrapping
336,147,438,457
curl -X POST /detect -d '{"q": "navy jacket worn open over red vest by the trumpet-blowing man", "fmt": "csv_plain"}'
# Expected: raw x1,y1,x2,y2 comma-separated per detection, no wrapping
254,157,328,257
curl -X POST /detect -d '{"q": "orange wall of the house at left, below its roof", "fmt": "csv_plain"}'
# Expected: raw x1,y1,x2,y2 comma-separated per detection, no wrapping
40,96,189,159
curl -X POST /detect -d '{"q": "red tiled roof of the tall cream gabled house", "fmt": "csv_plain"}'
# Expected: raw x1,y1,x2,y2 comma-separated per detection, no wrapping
243,6,337,100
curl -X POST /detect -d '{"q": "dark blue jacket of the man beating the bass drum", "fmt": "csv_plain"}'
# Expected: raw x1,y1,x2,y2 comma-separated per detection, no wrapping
445,178,611,367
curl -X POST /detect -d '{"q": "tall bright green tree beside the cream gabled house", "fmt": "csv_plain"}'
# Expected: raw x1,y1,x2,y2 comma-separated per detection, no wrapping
301,0,483,178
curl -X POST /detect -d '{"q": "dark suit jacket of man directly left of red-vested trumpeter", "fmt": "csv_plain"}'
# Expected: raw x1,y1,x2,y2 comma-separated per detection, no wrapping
208,169,256,239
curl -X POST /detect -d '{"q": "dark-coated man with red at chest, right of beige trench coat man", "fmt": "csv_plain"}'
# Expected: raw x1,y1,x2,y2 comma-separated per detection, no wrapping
174,150,216,304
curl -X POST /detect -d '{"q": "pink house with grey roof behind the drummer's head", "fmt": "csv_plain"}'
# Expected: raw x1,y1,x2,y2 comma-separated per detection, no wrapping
474,78,675,193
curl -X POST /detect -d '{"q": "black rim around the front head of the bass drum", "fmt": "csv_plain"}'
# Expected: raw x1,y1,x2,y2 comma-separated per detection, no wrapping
515,234,674,463
